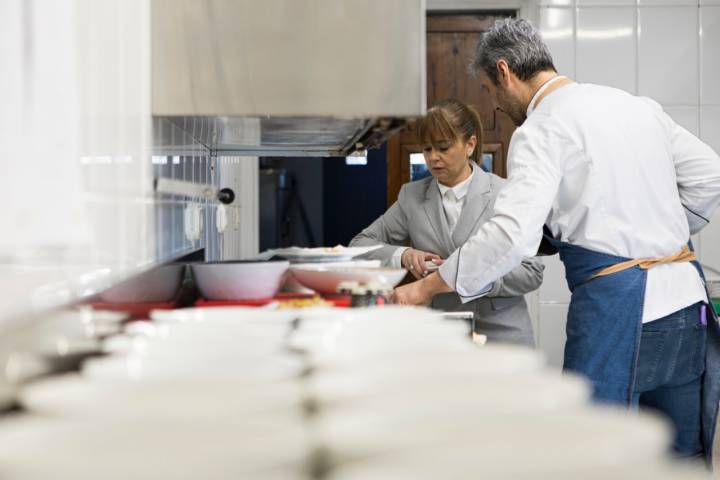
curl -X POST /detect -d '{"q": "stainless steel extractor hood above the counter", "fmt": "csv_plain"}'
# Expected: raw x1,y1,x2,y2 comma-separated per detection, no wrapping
152,0,426,156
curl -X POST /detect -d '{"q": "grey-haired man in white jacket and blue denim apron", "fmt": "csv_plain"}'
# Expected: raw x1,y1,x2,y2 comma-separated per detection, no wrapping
394,19,720,457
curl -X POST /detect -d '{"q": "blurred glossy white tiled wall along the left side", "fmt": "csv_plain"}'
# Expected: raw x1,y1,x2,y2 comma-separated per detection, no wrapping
0,0,239,324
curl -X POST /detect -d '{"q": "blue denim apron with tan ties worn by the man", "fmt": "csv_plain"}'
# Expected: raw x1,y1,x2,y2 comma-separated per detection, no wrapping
545,235,720,459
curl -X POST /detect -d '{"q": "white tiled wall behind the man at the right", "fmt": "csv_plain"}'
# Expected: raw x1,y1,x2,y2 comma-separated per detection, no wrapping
531,0,720,366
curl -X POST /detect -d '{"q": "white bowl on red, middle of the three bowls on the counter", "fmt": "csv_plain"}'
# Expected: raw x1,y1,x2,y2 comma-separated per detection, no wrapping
191,261,290,300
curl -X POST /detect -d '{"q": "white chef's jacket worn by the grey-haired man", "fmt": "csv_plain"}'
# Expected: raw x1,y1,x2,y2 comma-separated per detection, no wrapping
440,84,720,322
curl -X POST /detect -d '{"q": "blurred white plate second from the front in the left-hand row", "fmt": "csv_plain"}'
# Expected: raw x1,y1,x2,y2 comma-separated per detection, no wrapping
19,374,305,422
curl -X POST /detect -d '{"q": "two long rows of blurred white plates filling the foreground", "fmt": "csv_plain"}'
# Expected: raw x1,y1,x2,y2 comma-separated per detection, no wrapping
7,306,702,480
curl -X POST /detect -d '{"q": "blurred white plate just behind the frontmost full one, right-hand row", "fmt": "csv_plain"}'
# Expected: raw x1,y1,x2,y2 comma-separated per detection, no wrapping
307,370,590,408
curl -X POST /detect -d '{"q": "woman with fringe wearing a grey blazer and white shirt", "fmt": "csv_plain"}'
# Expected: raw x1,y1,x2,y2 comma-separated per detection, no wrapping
350,99,544,345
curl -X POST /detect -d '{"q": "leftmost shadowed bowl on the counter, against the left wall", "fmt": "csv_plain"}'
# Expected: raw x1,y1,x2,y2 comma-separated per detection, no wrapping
100,264,185,303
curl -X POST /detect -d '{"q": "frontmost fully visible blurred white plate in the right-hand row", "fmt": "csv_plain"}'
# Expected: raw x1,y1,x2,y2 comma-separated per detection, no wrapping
316,406,670,479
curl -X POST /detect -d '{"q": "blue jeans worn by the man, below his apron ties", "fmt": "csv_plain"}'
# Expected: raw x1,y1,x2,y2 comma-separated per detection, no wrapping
633,304,706,458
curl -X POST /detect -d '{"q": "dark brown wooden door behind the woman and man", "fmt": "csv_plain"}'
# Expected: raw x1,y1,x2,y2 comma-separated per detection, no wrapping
387,12,515,205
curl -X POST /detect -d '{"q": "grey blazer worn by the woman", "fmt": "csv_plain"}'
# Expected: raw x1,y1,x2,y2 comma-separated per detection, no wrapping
350,168,545,345
